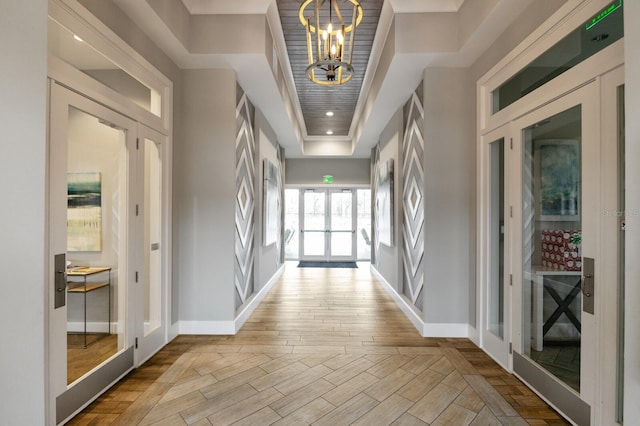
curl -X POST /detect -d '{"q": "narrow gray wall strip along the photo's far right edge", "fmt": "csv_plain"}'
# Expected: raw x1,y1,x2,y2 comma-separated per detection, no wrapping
624,1,640,424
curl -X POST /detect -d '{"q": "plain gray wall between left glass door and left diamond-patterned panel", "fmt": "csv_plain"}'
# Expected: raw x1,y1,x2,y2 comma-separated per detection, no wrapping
174,69,236,326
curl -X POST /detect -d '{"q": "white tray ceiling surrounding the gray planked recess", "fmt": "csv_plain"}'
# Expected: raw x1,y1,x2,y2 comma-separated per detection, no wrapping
113,0,539,158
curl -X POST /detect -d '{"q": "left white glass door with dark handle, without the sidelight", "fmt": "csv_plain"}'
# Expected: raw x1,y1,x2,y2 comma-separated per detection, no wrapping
48,83,137,423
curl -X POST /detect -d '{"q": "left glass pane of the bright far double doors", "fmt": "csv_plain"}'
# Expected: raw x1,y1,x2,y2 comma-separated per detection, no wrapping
302,191,327,258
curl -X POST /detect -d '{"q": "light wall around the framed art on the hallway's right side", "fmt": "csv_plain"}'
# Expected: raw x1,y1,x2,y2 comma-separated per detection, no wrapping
372,108,403,294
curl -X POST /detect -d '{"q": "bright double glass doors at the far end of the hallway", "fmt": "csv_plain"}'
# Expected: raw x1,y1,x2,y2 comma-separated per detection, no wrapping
300,189,356,261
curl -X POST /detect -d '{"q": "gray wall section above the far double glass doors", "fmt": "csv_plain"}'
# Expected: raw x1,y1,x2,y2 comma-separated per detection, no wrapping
285,158,371,186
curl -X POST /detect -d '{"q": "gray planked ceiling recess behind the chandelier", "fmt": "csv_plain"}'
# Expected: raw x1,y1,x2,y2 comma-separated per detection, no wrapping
276,0,383,136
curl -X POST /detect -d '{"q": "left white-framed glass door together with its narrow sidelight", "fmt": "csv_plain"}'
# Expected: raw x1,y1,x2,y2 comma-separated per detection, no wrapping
48,82,167,423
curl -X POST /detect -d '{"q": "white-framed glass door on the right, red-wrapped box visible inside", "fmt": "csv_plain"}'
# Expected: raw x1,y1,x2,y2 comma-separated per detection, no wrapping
512,77,618,425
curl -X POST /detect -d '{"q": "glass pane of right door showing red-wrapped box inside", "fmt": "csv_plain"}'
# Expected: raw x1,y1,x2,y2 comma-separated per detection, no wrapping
522,105,582,392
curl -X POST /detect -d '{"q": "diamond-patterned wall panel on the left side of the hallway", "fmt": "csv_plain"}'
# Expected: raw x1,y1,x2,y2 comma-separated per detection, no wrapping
234,88,256,308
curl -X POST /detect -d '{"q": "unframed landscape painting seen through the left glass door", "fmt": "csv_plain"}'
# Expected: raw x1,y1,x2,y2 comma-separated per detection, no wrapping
67,172,102,251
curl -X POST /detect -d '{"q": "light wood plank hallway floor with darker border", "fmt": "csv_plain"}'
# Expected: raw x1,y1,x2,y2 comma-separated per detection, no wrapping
70,264,568,426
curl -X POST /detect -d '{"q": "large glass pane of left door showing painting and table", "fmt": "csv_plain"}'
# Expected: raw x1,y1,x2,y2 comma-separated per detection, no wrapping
66,106,127,384
